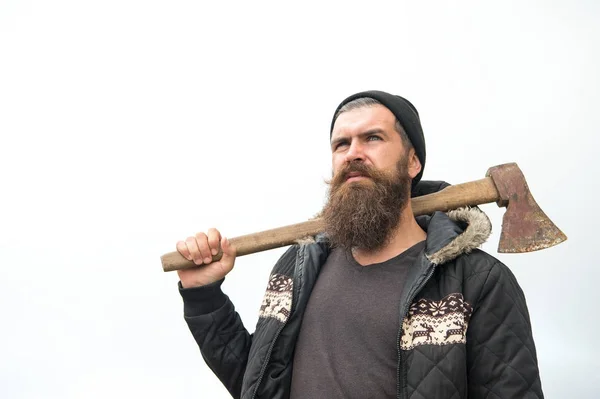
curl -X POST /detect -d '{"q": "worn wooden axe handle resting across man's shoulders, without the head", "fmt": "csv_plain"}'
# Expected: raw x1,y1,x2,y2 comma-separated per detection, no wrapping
161,177,499,272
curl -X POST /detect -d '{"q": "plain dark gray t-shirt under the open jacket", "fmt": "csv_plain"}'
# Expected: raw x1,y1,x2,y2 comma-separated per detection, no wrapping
291,241,425,399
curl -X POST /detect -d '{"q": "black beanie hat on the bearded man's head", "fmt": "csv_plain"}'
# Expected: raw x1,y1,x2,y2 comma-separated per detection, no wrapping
329,90,425,187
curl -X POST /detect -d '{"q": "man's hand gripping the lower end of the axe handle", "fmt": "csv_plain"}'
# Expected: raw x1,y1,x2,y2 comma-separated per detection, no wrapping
177,229,236,288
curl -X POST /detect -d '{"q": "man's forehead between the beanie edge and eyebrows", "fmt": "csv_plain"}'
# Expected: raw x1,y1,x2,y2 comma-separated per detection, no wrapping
331,104,396,139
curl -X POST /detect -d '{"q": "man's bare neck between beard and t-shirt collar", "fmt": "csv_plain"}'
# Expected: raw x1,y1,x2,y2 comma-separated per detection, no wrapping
352,203,427,266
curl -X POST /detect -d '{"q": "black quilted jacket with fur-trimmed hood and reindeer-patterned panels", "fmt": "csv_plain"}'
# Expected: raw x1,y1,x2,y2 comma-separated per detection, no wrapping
180,188,543,399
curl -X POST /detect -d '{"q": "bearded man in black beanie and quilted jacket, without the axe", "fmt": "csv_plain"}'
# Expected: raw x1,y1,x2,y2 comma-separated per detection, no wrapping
177,91,543,399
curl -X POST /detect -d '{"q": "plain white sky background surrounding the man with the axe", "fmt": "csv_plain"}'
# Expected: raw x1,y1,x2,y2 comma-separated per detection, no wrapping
0,0,600,398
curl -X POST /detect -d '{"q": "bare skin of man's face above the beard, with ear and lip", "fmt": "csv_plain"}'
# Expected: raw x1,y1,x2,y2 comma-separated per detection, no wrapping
331,105,420,183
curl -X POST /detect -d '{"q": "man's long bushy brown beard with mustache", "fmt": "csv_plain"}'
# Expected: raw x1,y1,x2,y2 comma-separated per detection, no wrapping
322,157,411,251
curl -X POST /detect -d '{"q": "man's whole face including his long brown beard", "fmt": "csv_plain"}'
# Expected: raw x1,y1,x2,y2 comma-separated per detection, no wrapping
322,106,420,250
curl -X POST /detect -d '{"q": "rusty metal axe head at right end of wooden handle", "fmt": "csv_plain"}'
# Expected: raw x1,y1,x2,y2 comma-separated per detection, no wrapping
486,163,567,253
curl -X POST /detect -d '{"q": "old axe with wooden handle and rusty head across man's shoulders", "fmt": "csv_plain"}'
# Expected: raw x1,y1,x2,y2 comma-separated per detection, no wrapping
161,163,567,272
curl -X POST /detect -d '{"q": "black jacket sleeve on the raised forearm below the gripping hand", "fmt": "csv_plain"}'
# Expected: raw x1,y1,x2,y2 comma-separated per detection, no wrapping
179,280,252,398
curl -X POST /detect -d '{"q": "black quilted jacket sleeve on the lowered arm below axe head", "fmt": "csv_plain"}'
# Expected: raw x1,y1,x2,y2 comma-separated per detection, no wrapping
467,261,544,399
